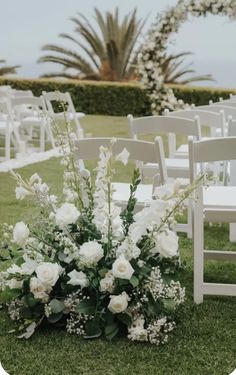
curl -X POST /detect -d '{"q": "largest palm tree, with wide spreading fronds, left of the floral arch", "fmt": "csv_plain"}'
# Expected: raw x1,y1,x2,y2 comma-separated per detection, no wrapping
38,8,145,81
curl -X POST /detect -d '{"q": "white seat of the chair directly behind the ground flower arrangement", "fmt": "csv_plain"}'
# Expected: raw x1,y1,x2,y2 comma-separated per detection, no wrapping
112,182,153,206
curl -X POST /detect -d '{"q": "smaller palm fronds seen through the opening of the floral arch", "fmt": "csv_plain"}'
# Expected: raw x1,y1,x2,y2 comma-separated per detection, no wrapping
162,52,214,85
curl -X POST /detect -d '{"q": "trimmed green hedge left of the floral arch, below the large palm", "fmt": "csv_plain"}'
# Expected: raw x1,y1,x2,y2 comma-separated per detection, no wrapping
0,78,150,116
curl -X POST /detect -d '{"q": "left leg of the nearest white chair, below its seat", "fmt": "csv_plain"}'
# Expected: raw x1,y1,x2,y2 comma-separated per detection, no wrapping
193,202,204,304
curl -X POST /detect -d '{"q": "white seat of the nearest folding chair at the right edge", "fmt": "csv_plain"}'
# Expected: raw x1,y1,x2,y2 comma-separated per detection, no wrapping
203,186,236,210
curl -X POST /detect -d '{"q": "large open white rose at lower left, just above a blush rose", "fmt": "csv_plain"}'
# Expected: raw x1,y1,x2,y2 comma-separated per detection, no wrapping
35,262,62,288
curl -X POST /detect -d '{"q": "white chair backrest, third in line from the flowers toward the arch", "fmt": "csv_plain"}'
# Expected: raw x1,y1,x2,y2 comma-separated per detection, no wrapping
165,107,225,136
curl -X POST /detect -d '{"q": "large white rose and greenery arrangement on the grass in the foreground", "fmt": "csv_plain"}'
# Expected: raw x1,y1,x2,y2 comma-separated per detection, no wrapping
0,125,205,345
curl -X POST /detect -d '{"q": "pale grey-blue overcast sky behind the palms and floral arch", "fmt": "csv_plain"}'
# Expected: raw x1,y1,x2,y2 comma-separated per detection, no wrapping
0,0,236,88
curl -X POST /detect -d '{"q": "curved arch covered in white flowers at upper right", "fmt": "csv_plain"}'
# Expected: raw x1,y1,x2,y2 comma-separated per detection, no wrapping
138,0,236,114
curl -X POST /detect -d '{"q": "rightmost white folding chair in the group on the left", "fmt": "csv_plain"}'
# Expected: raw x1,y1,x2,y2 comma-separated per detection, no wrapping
42,91,85,138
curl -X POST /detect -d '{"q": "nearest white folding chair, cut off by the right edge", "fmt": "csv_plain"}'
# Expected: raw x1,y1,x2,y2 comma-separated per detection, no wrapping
189,137,236,303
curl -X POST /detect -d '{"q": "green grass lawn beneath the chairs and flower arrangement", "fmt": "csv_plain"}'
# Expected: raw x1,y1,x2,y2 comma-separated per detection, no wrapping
0,116,236,375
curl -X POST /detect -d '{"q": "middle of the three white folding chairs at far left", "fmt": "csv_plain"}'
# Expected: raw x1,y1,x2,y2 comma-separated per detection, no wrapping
11,96,55,151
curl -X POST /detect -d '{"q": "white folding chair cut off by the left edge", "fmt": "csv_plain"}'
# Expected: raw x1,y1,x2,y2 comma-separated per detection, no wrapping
0,101,22,160
